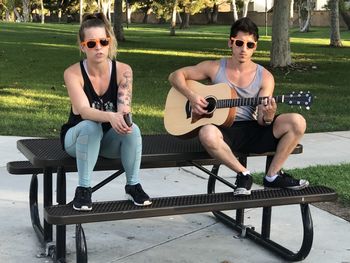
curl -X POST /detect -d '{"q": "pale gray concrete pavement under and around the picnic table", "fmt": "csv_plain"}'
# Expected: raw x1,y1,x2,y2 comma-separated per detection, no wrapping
0,131,350,263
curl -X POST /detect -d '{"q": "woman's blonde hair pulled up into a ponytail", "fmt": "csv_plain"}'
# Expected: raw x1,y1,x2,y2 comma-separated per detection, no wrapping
78,13,117,59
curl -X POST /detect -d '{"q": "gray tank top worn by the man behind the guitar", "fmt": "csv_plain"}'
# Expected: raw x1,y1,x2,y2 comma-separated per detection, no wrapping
213,58,263,121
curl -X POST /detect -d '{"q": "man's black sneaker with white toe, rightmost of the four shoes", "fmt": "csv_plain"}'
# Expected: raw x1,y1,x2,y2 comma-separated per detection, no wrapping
264,171,309,190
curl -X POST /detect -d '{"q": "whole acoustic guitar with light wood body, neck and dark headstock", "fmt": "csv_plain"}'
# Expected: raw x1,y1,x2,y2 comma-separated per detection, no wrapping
164,80,313,137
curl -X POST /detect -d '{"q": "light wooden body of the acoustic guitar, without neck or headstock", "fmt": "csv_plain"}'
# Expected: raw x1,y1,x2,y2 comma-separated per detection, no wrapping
164,80,237,138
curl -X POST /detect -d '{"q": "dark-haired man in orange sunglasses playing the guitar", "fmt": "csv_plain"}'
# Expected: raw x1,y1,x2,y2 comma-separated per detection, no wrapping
169,18,309,195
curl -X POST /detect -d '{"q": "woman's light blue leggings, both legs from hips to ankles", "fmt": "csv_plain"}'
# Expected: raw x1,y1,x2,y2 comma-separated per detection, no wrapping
64,120,142,187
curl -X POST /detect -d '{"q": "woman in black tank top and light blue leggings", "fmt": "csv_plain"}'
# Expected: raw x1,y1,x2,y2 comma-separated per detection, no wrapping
61,13,151,211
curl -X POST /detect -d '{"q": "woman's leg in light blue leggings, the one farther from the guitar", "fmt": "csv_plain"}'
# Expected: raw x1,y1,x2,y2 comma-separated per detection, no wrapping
64,120,103,187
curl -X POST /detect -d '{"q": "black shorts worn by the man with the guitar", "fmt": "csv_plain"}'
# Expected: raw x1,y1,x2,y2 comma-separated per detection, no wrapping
219,121,278,153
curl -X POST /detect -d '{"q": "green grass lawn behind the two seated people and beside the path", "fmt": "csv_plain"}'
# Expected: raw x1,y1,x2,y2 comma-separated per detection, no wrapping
0,22,350,204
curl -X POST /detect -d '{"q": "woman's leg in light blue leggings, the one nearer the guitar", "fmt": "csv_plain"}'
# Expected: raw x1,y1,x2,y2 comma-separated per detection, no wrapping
100,123,142,185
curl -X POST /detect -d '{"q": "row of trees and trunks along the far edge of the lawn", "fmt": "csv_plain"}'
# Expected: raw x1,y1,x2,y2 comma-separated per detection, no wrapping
0,0,350,67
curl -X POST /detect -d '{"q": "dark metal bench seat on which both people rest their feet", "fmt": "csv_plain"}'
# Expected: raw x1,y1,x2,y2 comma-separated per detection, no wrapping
44,186,337,225
